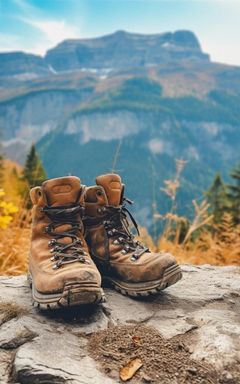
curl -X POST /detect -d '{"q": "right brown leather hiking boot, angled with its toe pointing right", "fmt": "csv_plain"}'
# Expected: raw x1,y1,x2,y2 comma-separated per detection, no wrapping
84,174,182,296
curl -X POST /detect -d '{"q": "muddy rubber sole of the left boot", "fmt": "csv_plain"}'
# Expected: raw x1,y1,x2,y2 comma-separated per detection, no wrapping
28,275,105,309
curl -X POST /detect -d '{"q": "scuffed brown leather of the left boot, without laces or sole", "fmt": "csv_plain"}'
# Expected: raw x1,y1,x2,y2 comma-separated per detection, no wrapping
29,176,101,293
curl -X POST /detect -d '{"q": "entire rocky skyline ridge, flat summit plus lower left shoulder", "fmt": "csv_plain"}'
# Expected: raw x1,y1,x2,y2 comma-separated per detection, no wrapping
0,30,209,78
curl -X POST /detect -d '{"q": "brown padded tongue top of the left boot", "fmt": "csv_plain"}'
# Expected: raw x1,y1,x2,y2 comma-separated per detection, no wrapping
42,176,81,207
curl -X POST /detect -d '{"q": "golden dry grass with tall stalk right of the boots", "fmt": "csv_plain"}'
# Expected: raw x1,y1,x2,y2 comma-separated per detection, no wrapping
140,160,240,265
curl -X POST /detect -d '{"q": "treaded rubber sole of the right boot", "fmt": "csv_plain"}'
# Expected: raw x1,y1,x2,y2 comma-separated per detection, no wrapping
103,264,182,297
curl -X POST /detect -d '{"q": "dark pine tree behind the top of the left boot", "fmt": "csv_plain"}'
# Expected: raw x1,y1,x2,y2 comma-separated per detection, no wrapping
23,145,47,188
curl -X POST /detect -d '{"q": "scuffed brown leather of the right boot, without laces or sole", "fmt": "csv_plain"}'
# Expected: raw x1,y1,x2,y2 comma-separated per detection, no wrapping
84,174,176,283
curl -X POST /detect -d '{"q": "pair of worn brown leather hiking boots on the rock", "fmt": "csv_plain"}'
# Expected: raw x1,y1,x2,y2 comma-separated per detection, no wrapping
29,174,181,308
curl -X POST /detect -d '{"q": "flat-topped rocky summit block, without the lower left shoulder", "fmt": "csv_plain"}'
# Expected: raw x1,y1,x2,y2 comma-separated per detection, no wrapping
46,31,209,71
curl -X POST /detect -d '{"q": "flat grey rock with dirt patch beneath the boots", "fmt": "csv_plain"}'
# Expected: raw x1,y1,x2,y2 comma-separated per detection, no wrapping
0,265,240,384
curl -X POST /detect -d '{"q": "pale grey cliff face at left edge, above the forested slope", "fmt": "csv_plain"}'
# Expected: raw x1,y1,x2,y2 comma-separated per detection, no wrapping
0,89,94,163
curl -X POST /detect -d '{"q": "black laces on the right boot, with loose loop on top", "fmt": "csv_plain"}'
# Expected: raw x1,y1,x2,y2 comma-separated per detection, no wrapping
103,198,149,261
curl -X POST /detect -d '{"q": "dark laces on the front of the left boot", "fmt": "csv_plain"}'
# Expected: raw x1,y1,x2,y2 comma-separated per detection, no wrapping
42,204,89,269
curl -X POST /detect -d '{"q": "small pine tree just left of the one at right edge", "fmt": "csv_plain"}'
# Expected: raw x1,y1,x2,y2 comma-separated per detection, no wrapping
205,173,229,223
